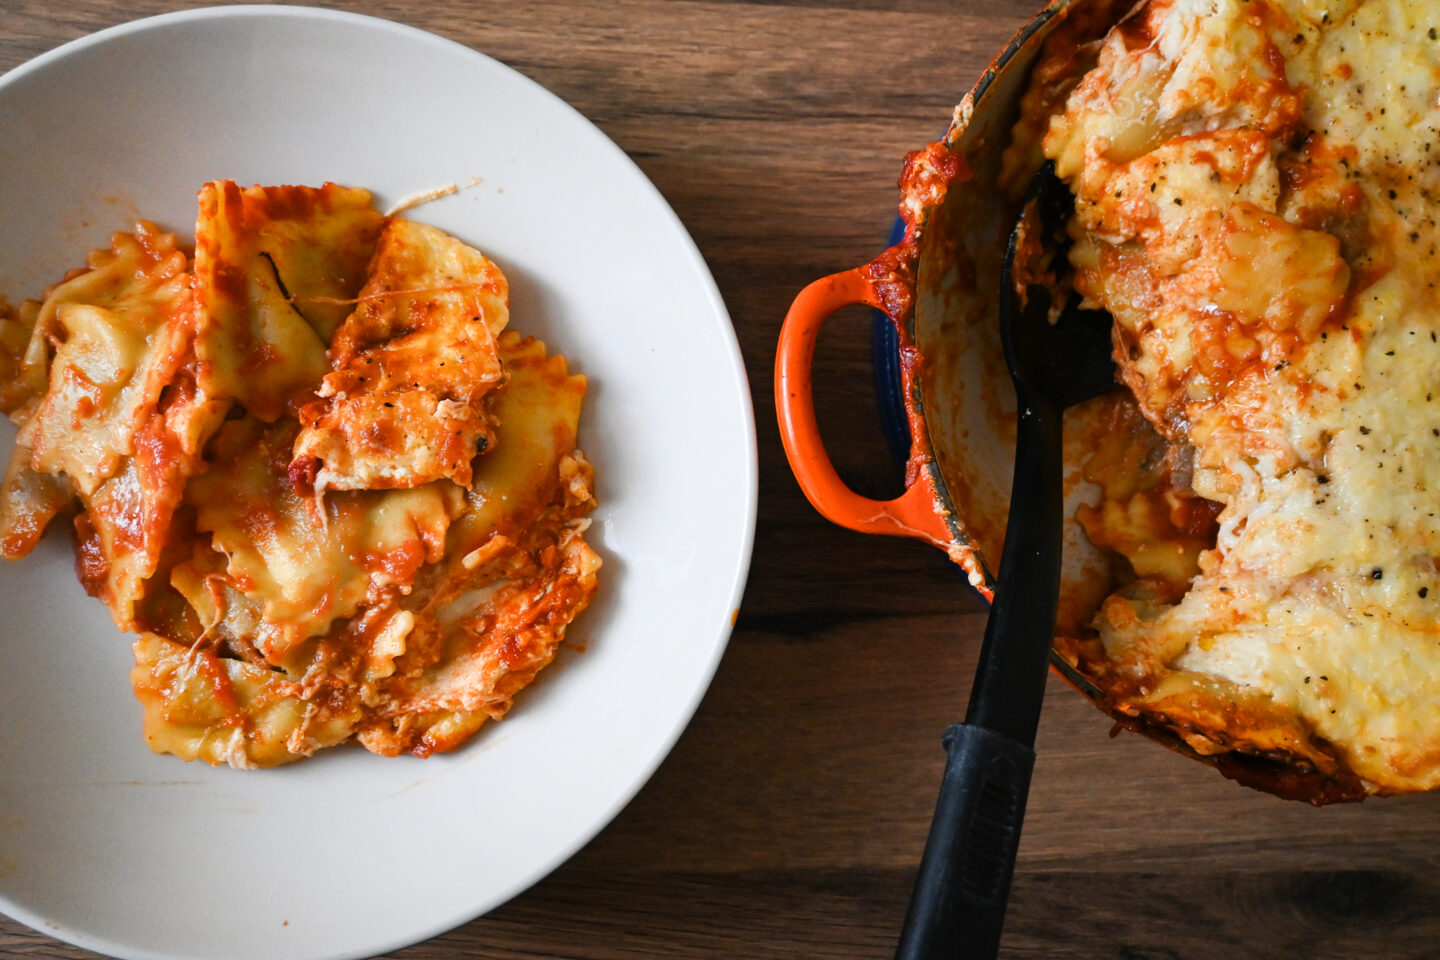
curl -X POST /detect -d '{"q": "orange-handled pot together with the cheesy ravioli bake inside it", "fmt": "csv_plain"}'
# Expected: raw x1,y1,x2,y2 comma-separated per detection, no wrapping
776,0,1440,803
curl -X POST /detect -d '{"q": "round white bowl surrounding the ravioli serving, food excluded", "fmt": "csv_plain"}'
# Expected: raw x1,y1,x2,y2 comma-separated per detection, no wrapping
0,7,756,960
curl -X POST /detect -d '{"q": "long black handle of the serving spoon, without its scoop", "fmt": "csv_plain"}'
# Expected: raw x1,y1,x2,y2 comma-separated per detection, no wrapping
896,396,1063,960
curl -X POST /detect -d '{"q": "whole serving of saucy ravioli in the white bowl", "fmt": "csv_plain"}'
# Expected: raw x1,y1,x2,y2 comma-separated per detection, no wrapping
0,181,600,769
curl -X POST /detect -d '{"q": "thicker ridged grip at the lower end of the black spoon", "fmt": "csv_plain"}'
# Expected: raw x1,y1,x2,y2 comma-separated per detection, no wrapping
896,724,1035,960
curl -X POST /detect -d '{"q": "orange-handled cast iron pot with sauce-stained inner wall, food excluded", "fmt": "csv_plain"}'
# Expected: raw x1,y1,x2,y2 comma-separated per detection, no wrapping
775,0,1365,803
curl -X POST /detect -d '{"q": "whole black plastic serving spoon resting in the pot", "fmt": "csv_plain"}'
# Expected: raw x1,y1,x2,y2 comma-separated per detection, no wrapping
896,164,1115,960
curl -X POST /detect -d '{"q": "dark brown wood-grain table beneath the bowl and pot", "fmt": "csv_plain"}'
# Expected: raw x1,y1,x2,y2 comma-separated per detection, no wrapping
0,0,1440,960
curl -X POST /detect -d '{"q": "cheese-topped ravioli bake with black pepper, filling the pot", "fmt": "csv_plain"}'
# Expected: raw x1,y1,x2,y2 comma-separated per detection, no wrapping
1013,0,1440,800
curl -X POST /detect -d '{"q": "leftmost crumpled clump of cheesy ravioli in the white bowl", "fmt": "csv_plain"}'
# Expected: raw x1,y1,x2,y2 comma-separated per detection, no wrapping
0,223,225,629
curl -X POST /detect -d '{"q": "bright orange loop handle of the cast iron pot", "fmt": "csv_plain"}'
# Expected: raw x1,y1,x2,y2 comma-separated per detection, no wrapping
775,268,950,547
